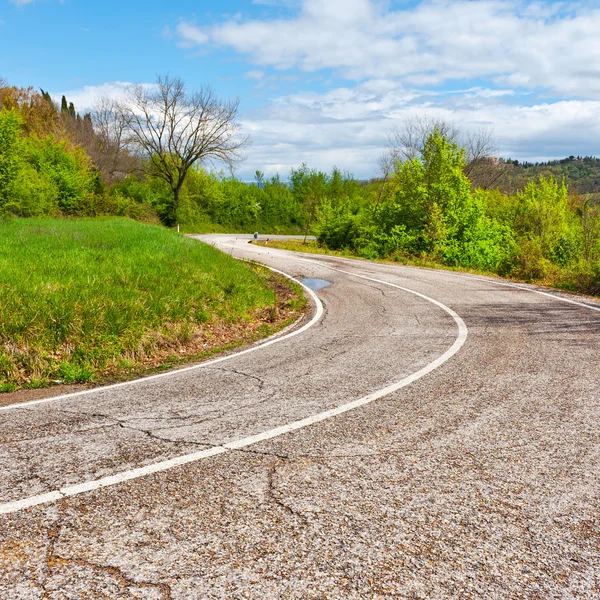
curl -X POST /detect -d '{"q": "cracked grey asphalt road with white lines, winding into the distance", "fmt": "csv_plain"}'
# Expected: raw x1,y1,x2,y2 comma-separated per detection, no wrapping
0,236,600,600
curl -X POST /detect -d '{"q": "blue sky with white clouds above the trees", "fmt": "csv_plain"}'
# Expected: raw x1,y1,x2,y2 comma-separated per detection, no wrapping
0,0,600,179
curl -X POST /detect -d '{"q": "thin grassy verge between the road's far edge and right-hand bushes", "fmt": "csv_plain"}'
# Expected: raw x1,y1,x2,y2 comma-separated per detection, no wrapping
258,240,600,296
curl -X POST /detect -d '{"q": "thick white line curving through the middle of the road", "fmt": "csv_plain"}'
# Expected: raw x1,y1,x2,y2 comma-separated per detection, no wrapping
0,267,468,514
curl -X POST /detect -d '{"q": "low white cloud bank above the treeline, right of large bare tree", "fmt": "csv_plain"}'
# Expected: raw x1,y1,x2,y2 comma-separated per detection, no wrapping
240,82,600,178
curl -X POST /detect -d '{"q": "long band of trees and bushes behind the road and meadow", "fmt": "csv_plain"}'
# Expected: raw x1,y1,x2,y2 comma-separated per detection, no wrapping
0,78,600,294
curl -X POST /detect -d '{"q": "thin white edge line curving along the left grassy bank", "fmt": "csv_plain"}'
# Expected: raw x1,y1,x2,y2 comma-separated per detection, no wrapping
0,265,323,413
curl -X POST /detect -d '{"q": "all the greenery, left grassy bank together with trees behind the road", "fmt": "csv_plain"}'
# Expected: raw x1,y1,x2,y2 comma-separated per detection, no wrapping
0,77,600,390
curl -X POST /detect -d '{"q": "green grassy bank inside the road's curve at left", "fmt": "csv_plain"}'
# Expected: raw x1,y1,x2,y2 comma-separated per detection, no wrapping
0,218,305,391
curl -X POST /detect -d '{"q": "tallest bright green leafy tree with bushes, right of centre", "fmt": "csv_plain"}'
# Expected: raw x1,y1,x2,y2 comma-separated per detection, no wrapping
319,130,512,270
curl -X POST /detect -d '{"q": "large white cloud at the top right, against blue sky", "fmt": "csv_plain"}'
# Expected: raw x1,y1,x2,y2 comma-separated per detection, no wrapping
177,0,600,97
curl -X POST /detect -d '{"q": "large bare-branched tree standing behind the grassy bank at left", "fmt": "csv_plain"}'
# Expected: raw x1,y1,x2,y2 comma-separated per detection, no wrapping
118,75,247,223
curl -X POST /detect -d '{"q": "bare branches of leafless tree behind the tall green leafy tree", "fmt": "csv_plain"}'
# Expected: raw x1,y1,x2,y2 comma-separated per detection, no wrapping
388,115,506,188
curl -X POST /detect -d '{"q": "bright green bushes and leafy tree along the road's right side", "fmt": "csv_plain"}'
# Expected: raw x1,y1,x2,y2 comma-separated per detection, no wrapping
318,129,600,294
